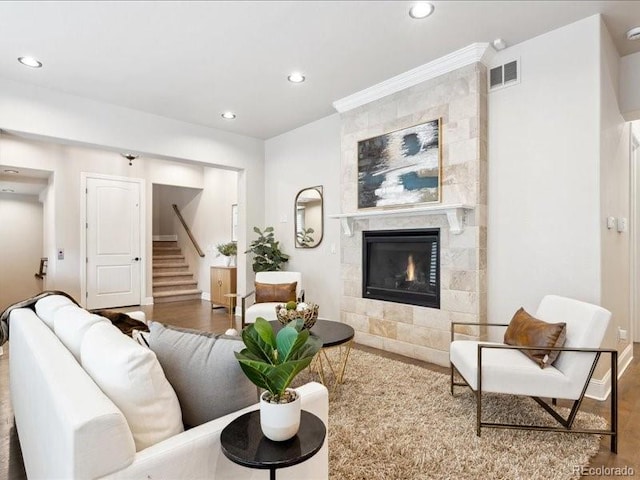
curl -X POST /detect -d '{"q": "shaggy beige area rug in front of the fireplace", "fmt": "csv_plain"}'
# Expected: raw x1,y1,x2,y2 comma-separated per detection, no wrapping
300,349,607,480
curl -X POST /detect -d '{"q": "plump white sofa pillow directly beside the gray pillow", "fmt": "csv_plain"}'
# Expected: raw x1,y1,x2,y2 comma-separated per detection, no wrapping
81,322,184,451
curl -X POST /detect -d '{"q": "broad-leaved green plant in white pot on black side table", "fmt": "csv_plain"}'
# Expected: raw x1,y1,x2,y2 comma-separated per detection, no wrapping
235,317,322,442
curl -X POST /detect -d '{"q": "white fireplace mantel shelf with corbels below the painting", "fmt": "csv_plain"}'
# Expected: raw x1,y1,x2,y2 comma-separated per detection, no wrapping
328,203,475,237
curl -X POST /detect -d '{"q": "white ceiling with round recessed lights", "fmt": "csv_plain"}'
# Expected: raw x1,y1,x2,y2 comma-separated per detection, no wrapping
0,1,640,138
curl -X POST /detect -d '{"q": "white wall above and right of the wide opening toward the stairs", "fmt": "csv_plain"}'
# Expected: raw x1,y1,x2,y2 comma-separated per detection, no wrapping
0,79,264,291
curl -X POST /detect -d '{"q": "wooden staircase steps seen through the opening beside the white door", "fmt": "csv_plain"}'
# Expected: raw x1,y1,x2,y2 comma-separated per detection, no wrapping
153,241,202,303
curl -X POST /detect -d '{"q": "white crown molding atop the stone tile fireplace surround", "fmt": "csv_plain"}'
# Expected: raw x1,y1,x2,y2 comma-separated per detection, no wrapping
333,43,495,113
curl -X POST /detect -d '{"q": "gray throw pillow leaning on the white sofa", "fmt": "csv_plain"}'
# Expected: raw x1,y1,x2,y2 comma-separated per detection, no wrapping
149,322,258,427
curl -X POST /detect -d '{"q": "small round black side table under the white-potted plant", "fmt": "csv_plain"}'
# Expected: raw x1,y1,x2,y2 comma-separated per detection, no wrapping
220,410,327,480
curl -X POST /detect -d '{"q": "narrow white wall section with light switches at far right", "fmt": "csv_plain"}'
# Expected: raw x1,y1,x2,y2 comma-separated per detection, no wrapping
600,18,631,352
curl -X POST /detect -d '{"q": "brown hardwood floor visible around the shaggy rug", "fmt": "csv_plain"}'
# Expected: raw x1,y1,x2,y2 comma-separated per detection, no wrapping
0,300,640,480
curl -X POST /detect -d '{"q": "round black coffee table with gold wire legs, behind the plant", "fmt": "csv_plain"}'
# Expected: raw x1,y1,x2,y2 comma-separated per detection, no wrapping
269,319,355,391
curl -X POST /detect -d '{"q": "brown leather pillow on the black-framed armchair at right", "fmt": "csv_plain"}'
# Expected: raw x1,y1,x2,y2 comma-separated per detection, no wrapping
504,307,567,368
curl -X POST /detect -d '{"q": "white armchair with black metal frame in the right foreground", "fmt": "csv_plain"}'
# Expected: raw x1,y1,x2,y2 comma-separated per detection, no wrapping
450,295,618,453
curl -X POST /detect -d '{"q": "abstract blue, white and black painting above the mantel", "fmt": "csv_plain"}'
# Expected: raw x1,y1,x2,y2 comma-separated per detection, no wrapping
356,117,442,210
